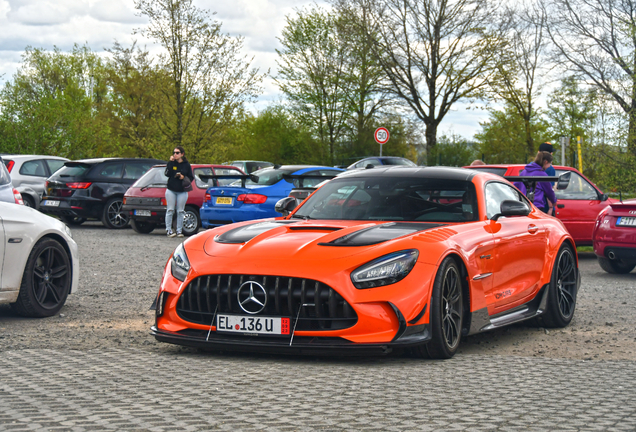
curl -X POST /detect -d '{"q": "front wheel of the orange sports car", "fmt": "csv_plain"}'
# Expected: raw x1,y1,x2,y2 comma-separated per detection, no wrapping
416,257,464,359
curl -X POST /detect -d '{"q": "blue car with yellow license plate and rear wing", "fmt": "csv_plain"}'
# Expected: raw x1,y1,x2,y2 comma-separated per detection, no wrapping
199,165,344,228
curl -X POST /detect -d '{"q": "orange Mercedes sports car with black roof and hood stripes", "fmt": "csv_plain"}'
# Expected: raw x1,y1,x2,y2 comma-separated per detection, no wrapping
152,167,580,358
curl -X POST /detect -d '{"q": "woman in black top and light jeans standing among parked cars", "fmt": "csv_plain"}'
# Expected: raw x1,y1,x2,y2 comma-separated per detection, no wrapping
165,146,194,237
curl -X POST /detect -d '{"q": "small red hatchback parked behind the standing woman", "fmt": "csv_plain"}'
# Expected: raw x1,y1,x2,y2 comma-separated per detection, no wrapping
122,164,243,236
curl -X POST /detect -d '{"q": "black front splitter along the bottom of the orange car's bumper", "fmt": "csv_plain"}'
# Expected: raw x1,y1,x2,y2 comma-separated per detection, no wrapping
150,324,431,356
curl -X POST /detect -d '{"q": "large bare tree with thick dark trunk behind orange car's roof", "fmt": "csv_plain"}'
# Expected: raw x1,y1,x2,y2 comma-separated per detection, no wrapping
335,0,502,155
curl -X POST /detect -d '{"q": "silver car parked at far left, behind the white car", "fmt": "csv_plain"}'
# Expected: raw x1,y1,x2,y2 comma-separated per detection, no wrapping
2,155,68,209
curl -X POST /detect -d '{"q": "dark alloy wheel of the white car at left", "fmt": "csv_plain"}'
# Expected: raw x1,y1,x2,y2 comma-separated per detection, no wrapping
11,238,72,317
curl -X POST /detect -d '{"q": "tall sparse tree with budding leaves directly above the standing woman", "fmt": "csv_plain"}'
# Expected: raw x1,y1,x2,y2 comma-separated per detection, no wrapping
135,0,263,159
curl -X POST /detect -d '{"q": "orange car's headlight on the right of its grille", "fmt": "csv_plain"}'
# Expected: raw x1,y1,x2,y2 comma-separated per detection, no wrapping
351,249,419,289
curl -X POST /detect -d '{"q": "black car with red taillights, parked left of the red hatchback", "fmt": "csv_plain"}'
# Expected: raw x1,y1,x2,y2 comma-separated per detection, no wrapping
40,158,165,228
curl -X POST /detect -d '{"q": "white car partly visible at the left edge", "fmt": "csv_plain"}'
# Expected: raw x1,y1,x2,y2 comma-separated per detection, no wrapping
0,202,79,317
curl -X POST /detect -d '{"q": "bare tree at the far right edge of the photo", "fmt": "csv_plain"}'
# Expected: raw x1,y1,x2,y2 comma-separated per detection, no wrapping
544,0,636,155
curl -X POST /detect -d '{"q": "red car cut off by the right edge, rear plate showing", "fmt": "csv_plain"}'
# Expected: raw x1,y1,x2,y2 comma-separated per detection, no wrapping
593,199,636,273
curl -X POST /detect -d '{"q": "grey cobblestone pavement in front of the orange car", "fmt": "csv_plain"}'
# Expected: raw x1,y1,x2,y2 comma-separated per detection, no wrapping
0,349,636,431
